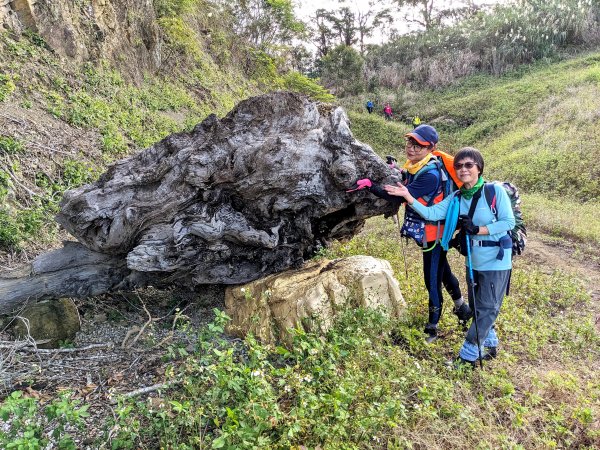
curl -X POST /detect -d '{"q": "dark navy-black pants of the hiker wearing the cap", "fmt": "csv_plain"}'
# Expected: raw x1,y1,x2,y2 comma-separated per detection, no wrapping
423,242,462,324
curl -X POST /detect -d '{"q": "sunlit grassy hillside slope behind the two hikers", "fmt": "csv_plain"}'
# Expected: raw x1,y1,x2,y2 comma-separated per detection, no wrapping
346,54,600,245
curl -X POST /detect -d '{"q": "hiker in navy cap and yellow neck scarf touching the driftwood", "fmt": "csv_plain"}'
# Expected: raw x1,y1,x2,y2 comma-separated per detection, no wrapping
346,125,471,342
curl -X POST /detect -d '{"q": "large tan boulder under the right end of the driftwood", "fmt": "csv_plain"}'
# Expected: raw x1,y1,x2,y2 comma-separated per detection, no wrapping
225,256,406,343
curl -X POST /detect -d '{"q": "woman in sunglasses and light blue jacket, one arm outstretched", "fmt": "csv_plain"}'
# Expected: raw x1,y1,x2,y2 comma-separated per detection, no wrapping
384,147,515,365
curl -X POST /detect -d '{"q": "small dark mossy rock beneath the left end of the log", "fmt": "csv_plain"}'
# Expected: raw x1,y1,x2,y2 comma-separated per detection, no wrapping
12,298,81,348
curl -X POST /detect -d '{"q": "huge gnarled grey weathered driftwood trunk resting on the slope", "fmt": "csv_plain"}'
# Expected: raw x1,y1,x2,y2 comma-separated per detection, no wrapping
0,92,404,312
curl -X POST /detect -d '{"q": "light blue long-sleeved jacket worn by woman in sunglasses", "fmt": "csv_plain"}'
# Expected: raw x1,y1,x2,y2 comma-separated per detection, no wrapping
411,184,515,271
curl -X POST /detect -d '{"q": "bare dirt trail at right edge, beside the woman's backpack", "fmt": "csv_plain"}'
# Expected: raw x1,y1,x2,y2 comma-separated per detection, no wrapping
516,232,600,333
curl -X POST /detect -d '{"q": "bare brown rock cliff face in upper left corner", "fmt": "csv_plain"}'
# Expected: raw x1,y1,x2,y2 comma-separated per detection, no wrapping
0,0,163,80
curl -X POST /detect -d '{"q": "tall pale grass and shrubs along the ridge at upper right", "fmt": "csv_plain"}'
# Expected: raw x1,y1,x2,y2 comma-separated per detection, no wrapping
313,0,600,92
